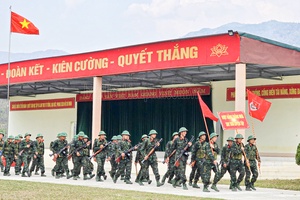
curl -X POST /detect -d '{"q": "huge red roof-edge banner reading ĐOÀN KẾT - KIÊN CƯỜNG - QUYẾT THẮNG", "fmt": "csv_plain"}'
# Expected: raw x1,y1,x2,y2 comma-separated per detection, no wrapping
0,34,240,85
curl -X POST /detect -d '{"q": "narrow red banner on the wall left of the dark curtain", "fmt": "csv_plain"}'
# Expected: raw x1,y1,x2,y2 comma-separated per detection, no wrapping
10,98,75,111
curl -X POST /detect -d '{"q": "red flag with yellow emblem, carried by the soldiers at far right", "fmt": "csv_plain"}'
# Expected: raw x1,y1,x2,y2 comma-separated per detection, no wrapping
247,90,271,121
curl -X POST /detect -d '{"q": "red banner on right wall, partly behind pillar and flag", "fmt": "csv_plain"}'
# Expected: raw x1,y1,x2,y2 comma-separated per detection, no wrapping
226,84,300,101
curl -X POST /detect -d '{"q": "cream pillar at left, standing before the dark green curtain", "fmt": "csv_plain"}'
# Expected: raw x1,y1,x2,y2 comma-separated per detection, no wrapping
92,77,102,141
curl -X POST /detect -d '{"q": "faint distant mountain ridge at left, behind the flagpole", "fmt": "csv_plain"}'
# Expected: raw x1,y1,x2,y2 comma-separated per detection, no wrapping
0,49,68,63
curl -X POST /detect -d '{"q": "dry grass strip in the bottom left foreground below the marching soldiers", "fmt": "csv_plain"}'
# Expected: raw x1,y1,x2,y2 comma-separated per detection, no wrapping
0,180,220,200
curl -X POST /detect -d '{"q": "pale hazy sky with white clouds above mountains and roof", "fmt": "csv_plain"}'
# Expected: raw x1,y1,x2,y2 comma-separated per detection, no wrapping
0,0,300,53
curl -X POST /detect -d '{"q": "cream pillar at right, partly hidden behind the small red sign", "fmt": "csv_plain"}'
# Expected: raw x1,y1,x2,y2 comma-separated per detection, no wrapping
235,63,246,138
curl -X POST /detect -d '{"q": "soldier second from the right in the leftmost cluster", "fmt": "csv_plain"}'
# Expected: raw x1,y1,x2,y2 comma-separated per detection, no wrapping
19,133,38,177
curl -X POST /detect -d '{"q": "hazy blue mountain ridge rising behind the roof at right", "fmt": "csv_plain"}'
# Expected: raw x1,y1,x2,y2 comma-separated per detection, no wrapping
184,20,300,47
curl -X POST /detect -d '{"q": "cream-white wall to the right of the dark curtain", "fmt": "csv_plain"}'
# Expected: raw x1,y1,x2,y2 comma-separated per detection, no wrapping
212,76,300,154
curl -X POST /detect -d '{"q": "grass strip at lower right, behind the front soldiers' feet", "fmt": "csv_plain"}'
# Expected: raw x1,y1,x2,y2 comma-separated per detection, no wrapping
218,179,300,191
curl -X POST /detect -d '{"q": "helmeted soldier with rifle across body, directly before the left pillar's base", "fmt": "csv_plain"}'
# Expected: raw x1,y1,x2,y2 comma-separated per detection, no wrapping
93,131,107,182
